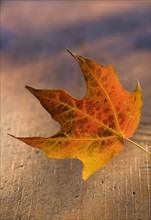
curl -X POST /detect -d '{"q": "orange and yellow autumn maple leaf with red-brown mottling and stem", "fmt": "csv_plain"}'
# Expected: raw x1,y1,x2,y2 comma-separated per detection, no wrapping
9,49,151,180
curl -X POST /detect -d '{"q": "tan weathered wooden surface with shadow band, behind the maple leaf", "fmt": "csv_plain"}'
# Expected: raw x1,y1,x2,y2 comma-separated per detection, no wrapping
0,1,151,220
